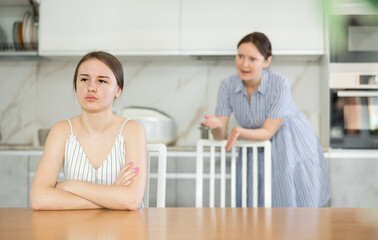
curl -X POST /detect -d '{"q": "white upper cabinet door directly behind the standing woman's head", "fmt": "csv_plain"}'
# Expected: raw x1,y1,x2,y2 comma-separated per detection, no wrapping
181,0,324,54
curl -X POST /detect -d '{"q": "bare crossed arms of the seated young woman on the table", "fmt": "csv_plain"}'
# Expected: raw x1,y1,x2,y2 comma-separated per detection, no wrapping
30,122,147,210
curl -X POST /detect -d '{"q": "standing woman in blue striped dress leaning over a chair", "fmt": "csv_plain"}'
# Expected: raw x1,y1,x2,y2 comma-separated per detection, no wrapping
203,32,330,207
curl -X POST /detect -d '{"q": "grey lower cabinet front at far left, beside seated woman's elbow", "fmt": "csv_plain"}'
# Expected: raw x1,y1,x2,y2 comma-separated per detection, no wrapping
0,153,28,207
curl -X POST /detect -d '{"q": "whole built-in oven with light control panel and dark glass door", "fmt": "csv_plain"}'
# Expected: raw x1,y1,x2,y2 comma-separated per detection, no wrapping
330,72,378,149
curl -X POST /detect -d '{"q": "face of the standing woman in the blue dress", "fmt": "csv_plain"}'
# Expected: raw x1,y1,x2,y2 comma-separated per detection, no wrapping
235,43,272,82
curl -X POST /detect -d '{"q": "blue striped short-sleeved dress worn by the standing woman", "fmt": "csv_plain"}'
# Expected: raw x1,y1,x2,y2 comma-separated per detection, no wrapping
216,69,330,207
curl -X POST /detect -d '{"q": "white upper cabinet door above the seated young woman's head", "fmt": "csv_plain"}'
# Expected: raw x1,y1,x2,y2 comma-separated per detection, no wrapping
39,0,179,55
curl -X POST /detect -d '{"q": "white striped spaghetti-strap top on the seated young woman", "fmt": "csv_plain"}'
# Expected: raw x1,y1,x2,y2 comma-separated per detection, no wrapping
63,119,128,185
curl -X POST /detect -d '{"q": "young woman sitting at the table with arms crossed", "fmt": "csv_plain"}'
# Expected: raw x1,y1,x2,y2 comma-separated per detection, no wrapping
30,52,147,210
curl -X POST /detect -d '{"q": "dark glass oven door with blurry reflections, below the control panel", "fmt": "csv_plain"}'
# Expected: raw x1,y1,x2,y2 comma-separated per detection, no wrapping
330,89,378,149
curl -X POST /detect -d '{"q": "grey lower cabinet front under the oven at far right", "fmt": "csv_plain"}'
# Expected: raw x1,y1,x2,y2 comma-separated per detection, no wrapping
330,158,378,208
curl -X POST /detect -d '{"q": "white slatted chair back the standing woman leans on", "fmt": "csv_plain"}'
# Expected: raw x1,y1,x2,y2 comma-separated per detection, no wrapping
196,139,272,207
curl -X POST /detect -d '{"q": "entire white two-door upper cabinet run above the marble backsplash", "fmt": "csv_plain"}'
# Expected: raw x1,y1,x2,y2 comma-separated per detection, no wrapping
39,0,324,56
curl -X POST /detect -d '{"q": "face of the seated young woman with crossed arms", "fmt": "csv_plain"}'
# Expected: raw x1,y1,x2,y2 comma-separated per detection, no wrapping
76,59,121,112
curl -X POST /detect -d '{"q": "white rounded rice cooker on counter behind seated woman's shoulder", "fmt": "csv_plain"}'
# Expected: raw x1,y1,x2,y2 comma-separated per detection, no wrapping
120,107,176,145
